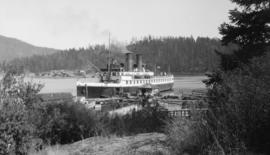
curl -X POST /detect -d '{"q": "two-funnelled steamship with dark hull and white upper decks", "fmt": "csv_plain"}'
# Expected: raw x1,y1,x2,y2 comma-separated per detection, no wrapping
77,53,174,99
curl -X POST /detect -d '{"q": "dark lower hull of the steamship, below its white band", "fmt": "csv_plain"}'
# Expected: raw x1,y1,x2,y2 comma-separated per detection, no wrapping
77,83,173,98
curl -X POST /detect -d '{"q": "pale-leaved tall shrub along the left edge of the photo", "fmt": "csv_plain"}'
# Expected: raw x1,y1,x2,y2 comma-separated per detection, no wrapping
0,70,41,154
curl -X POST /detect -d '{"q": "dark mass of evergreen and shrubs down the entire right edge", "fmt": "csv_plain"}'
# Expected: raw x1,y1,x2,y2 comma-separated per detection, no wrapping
207,0,270,154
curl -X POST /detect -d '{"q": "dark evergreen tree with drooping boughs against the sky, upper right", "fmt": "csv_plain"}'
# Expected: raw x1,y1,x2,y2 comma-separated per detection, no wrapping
220,0,270,71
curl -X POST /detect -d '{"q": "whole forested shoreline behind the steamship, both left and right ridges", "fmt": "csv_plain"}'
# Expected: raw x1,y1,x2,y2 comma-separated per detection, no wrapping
1,37,234,73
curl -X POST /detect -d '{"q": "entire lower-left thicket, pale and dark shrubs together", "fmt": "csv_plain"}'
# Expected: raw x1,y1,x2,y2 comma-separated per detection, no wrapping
0,70,98,154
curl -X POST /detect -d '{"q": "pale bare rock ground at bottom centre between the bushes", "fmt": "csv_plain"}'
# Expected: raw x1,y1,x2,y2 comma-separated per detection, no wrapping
34,133,169,155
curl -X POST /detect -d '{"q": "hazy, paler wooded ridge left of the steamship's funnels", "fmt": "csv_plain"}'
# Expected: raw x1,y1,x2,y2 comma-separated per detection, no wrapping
1,45,122,73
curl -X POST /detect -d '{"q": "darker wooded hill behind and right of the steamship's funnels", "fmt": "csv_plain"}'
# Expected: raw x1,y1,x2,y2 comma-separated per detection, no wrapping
127,37,232,73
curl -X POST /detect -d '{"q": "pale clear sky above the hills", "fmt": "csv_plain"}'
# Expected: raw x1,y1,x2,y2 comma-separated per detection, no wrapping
0,0,234,49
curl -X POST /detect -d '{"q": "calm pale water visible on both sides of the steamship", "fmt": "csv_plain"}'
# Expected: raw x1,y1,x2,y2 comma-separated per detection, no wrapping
26,76,206,95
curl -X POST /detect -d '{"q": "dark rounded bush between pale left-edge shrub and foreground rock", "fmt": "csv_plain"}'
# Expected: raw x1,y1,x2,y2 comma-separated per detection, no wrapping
34,101,97,144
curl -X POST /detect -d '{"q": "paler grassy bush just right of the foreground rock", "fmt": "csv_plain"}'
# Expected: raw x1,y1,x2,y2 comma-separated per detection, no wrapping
165,113,212,155
